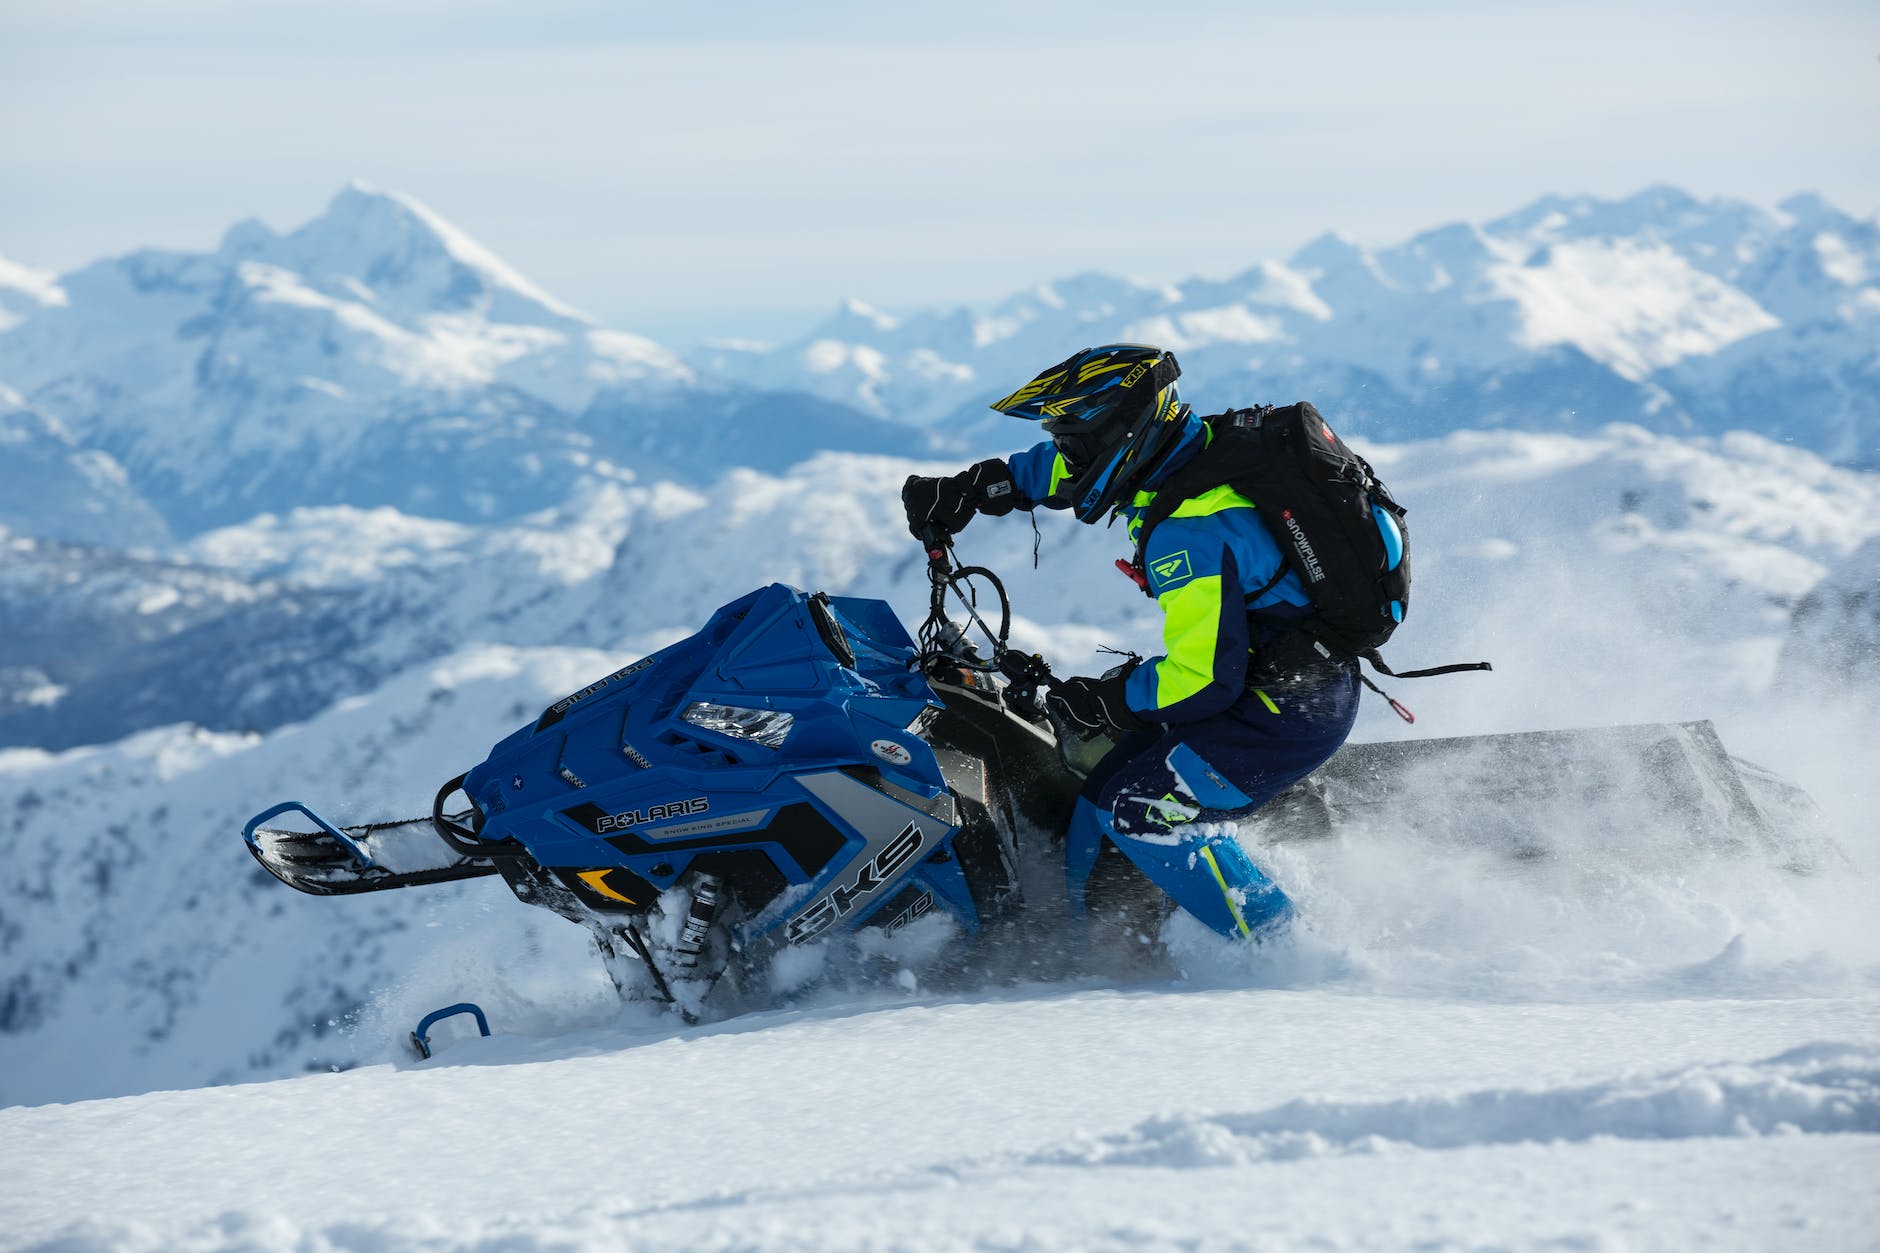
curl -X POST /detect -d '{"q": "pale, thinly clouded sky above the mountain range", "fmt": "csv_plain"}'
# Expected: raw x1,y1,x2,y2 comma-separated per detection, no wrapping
0,0,1880,341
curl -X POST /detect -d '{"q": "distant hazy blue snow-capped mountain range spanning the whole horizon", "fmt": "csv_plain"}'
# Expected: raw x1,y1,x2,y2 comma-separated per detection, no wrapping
0,182,1880,544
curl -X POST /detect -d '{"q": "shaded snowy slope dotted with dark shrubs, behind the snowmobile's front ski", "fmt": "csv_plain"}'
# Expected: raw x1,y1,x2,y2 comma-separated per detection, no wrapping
0,649,611,1101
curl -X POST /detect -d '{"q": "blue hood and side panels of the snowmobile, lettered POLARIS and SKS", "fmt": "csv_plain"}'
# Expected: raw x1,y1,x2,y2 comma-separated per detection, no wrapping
447,583,970,941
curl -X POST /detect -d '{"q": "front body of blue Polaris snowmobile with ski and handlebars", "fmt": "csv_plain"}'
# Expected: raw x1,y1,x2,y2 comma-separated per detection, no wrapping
243,536,1203,1008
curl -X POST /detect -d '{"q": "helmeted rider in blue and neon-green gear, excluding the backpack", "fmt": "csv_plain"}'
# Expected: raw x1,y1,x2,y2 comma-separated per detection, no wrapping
901,344,1359,937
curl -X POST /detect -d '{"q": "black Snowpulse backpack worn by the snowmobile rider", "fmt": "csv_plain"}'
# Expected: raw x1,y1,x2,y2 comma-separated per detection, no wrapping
1134,401,1491,715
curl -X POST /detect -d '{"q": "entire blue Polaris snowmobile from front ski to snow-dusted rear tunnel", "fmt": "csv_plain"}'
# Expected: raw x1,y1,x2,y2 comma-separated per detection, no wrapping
243,534,1844,1016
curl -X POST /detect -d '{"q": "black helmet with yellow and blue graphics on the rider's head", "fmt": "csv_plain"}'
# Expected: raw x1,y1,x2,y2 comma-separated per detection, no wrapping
993,344,1188,523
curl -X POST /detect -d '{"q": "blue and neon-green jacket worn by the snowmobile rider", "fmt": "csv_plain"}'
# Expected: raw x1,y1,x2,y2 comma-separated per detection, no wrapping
1006,428,1312,722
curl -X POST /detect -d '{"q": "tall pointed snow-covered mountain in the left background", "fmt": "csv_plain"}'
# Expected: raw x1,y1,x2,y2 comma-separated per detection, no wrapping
0,184,916,532
